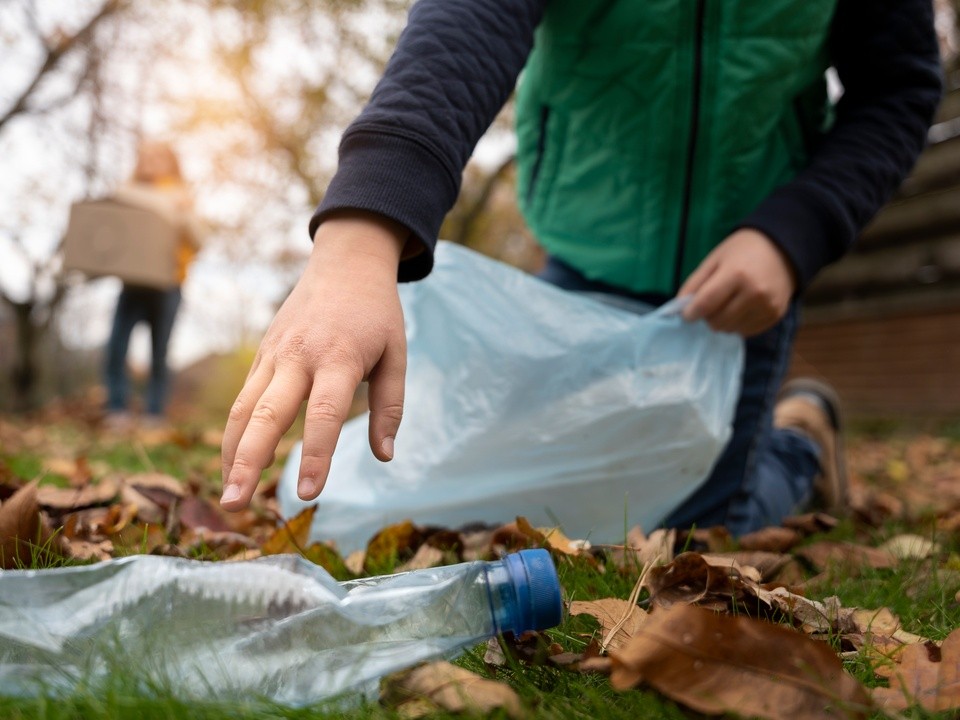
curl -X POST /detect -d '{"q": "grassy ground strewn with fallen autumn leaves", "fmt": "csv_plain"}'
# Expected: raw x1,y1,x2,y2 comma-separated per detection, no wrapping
0,405,960,719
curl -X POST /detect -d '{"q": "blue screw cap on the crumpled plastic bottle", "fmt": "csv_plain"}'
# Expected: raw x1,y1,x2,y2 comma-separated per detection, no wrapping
503,548,563,634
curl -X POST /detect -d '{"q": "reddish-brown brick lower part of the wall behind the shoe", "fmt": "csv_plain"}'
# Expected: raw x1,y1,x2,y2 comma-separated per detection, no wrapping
791,308,960,417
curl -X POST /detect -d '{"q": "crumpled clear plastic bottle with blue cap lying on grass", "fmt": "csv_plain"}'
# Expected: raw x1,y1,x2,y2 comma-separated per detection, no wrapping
0,550,562,706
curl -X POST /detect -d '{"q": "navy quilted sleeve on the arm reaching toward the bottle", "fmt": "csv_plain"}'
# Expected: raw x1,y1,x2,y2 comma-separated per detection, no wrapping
310,0,546,280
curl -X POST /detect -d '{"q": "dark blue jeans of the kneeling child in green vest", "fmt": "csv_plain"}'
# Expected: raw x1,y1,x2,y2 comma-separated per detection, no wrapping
540,258,820,536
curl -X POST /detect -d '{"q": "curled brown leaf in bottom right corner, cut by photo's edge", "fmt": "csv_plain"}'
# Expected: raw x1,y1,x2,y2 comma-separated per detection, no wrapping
873,630,960,712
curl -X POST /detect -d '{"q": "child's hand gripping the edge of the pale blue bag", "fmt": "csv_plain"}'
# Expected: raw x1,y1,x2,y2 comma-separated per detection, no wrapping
677,228,797,337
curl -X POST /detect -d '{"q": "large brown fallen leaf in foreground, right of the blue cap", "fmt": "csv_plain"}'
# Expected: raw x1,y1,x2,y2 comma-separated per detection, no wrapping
610,605,870,720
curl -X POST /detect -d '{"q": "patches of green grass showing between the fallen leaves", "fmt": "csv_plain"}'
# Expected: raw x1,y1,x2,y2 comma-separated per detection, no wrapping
0,425,960,720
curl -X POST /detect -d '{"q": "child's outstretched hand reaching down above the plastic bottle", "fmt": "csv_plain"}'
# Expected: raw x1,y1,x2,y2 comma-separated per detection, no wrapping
220,214,409,510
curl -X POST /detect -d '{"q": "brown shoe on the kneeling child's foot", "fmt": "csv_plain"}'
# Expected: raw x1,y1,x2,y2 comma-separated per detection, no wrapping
773,378,849,515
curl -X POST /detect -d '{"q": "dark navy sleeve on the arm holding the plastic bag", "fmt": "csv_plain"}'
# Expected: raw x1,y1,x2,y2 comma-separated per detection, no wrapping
741,0,941,288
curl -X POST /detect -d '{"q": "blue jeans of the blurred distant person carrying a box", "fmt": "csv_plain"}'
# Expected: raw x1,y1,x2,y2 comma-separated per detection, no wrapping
106,285,180,415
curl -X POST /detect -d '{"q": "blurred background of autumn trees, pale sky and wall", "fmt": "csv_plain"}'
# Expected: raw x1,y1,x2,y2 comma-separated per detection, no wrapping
0,0,960,421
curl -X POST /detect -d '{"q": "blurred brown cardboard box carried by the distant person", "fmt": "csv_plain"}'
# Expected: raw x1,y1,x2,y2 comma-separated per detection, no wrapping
63,199,181,288
